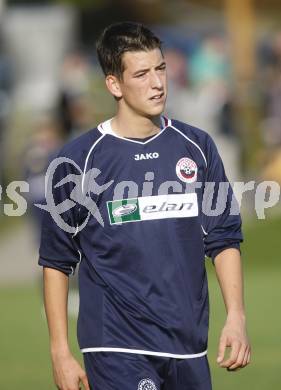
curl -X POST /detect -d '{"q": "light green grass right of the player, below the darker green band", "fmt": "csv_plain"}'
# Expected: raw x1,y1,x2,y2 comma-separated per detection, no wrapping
208,267,281,390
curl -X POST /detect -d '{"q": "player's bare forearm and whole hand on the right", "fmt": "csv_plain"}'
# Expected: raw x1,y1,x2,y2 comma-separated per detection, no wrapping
215,248,251,370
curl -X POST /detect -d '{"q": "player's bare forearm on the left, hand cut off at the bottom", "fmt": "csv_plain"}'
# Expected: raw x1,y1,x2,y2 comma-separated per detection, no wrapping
43,267,90,390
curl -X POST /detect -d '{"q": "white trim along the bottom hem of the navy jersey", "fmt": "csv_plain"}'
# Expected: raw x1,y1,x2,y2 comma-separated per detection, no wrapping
81,347,207,359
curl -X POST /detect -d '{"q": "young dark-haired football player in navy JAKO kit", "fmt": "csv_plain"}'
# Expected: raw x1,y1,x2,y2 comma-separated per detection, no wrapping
39,23,250,390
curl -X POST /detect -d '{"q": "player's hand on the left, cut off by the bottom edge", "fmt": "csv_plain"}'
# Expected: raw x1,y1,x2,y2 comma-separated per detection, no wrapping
52,352,90,390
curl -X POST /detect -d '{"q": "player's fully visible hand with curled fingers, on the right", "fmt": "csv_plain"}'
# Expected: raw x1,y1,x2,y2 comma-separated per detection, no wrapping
217,313,251,371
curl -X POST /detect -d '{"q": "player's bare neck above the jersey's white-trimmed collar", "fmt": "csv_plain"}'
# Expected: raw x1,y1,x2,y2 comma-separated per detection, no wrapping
111,113,161,138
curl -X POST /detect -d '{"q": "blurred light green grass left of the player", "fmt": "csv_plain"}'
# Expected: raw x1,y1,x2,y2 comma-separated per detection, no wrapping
0,286,79,390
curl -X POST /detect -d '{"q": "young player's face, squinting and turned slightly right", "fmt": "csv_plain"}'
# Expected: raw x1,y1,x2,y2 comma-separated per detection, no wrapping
116,49,167,117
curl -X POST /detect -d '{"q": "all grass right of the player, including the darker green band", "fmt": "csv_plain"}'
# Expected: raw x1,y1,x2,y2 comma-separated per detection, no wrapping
207,218,281,390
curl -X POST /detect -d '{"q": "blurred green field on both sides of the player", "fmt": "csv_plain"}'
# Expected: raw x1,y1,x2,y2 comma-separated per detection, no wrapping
0,218,281,390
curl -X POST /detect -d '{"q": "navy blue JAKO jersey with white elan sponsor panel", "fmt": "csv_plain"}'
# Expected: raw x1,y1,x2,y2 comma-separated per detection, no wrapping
39,116,242,358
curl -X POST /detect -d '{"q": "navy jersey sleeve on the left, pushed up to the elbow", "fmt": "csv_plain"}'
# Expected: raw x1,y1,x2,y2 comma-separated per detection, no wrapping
38,151,81,275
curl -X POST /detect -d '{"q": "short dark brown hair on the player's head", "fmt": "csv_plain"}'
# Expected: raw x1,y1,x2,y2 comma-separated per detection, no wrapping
96,22,162,78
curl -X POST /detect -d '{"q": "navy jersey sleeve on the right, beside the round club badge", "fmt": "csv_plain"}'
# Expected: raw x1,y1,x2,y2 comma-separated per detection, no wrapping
202,137,243,261
